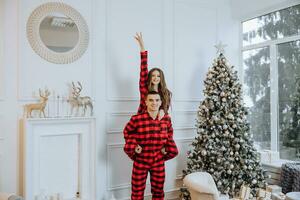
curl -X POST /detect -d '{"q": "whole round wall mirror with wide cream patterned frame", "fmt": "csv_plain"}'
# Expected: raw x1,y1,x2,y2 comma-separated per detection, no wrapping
27,2,89,64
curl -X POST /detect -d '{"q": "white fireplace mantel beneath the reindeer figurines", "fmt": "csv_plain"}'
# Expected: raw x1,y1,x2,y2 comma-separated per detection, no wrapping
23,117,96,200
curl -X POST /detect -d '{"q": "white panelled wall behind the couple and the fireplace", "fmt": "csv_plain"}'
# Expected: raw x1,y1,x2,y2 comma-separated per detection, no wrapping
0,0,239,200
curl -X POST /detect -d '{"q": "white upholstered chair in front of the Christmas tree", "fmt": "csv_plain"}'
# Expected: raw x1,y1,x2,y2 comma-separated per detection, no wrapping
183,172,229,200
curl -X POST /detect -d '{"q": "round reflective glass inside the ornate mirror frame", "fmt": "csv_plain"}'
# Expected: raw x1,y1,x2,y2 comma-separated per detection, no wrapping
39,13,79,53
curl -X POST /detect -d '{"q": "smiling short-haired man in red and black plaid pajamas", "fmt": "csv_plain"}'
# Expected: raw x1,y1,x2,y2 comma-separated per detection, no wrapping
124,91,178,200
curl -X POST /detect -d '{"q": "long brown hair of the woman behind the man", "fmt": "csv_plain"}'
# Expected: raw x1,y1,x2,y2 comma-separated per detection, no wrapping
147,67,172,113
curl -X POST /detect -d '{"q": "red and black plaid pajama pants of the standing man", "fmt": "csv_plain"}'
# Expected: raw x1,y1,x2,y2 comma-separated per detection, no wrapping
131,158,165,200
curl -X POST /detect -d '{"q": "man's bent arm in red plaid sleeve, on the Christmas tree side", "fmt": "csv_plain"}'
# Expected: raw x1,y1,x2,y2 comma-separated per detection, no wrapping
164,117,178,160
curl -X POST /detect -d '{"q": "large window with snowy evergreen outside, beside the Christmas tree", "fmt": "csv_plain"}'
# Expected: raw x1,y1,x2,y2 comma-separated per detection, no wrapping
242,5,300,160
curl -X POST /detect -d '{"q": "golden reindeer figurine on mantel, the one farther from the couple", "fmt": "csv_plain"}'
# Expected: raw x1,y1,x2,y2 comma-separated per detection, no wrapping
24,89,50,118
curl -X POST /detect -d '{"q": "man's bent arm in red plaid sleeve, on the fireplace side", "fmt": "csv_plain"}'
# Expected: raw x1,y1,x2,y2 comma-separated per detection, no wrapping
123,117,138,160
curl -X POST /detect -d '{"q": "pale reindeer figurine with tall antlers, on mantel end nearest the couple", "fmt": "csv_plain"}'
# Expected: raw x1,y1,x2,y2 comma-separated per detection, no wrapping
68,81,93,116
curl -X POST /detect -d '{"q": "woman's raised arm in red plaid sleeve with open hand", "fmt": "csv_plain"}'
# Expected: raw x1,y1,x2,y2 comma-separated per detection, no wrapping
134,33,148,113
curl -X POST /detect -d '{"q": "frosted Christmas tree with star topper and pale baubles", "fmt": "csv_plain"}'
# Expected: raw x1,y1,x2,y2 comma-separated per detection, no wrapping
181,45,266,199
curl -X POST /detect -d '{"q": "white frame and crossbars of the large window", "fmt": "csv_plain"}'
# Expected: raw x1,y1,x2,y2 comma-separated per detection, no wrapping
239,1,300,151
